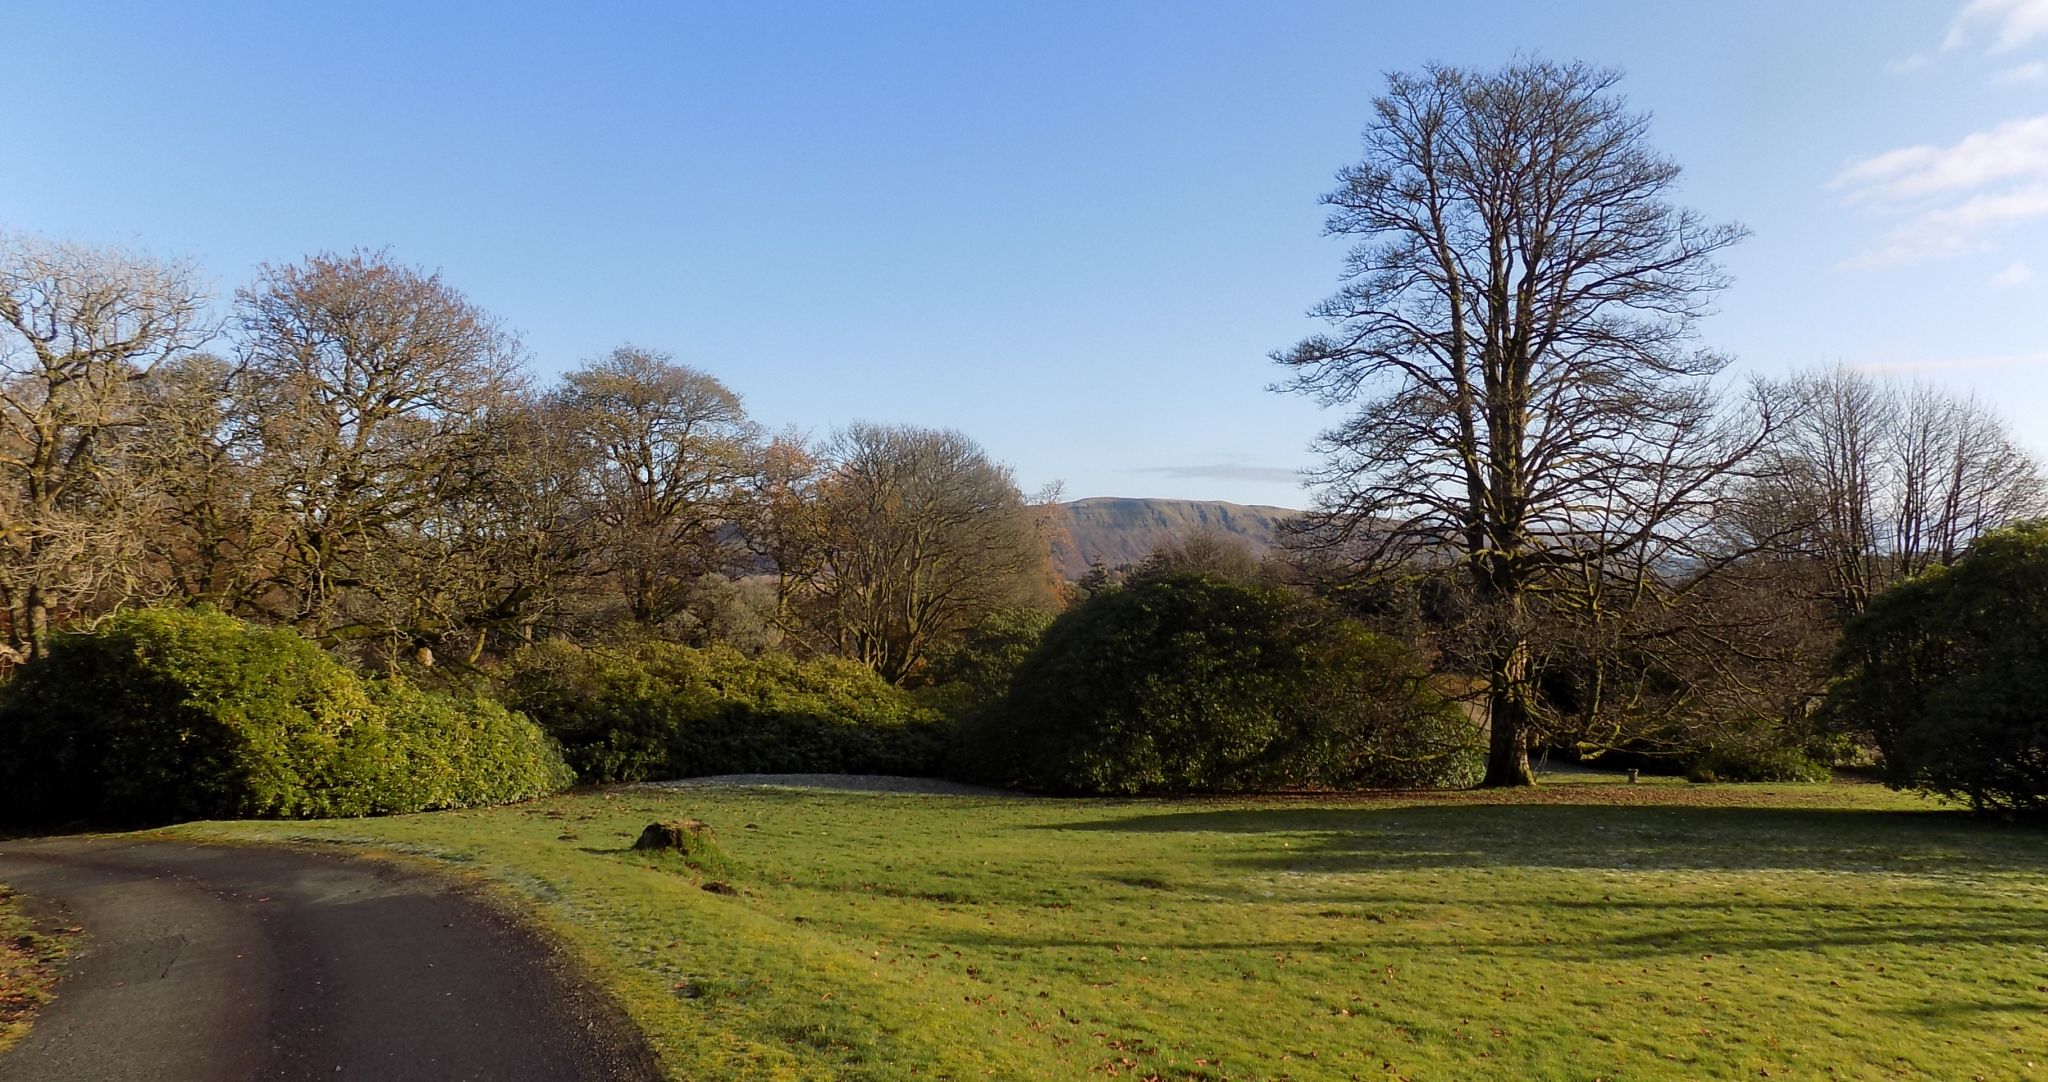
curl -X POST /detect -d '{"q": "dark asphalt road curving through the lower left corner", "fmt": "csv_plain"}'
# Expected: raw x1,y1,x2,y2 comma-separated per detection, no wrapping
0,838,659,1082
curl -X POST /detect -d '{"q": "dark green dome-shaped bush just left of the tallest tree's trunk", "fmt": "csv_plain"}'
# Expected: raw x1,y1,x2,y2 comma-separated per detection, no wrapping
963,574,1477,793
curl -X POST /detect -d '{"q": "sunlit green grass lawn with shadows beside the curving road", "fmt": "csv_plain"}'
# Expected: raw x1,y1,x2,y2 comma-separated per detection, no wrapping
180,785,2048,1082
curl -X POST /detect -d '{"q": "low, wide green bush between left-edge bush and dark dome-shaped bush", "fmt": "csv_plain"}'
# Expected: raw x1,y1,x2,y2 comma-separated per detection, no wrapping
502,641,946,781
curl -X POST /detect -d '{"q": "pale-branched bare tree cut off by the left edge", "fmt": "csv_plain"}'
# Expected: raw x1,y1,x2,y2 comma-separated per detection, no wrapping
0,238,211,656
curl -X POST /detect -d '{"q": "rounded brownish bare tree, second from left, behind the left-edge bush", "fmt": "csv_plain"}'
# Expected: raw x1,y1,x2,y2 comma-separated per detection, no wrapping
238,250,520,648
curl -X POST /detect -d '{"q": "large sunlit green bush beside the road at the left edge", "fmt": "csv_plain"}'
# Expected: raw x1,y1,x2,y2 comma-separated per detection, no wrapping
0,609,571,822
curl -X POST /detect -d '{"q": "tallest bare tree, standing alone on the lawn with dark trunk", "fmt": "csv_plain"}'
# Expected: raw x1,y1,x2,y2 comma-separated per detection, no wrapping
1274,61,1743,785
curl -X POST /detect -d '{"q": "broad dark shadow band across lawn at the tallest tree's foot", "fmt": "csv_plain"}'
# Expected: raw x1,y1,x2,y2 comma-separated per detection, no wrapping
1044,803,2048,875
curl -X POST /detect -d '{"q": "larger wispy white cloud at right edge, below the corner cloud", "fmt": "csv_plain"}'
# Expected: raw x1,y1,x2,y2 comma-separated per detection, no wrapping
1829,115,2048,266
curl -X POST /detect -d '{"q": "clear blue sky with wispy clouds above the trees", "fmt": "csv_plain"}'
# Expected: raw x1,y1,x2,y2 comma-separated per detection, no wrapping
0,0,2048,506
